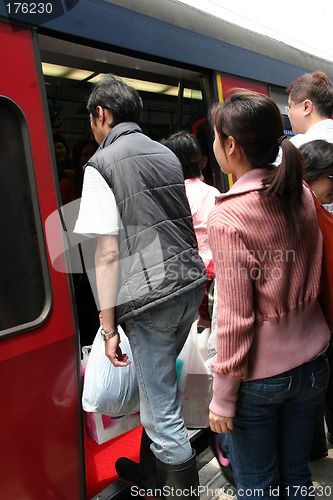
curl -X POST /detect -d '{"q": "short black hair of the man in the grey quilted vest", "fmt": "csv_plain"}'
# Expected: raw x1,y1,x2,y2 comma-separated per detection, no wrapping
87,74,143,127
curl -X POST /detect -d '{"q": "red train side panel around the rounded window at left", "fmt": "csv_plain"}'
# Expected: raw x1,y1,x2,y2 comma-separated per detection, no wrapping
0,22,85,500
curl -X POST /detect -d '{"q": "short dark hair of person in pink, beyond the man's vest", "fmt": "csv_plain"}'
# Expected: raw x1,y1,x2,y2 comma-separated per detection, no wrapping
161,130,201,179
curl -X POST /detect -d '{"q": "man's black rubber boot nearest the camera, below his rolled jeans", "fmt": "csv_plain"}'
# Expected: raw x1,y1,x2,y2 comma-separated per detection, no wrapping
156,450,200,500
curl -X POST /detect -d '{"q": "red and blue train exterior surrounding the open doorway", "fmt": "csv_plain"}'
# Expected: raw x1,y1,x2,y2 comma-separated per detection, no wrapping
0,0,333,500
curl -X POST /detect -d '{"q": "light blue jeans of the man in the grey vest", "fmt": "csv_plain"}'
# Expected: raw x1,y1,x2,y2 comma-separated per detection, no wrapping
126,284,205,464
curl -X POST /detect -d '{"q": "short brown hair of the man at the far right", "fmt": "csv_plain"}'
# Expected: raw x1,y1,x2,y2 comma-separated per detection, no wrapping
286,71,333,118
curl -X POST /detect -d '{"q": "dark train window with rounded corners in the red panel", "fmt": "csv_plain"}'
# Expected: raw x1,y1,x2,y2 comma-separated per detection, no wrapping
0,96,50,337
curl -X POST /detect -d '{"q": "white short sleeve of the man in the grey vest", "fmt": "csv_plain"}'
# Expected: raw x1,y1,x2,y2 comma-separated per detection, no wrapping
74,167,119,237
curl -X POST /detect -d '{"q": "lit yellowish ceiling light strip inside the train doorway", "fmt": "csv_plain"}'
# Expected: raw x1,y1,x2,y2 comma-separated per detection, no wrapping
42,63,202,100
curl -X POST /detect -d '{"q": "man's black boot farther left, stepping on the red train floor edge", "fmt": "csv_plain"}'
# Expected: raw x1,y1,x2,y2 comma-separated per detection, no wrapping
115,429,156,490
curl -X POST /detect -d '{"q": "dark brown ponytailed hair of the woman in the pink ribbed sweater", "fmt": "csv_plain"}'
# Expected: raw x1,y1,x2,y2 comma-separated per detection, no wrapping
209,89,304,238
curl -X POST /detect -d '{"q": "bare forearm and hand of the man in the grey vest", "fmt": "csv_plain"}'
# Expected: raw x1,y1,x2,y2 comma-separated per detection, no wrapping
95,235,130,366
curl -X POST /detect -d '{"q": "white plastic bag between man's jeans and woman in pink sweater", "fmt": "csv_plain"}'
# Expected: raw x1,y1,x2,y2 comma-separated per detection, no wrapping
178,321,213,429
